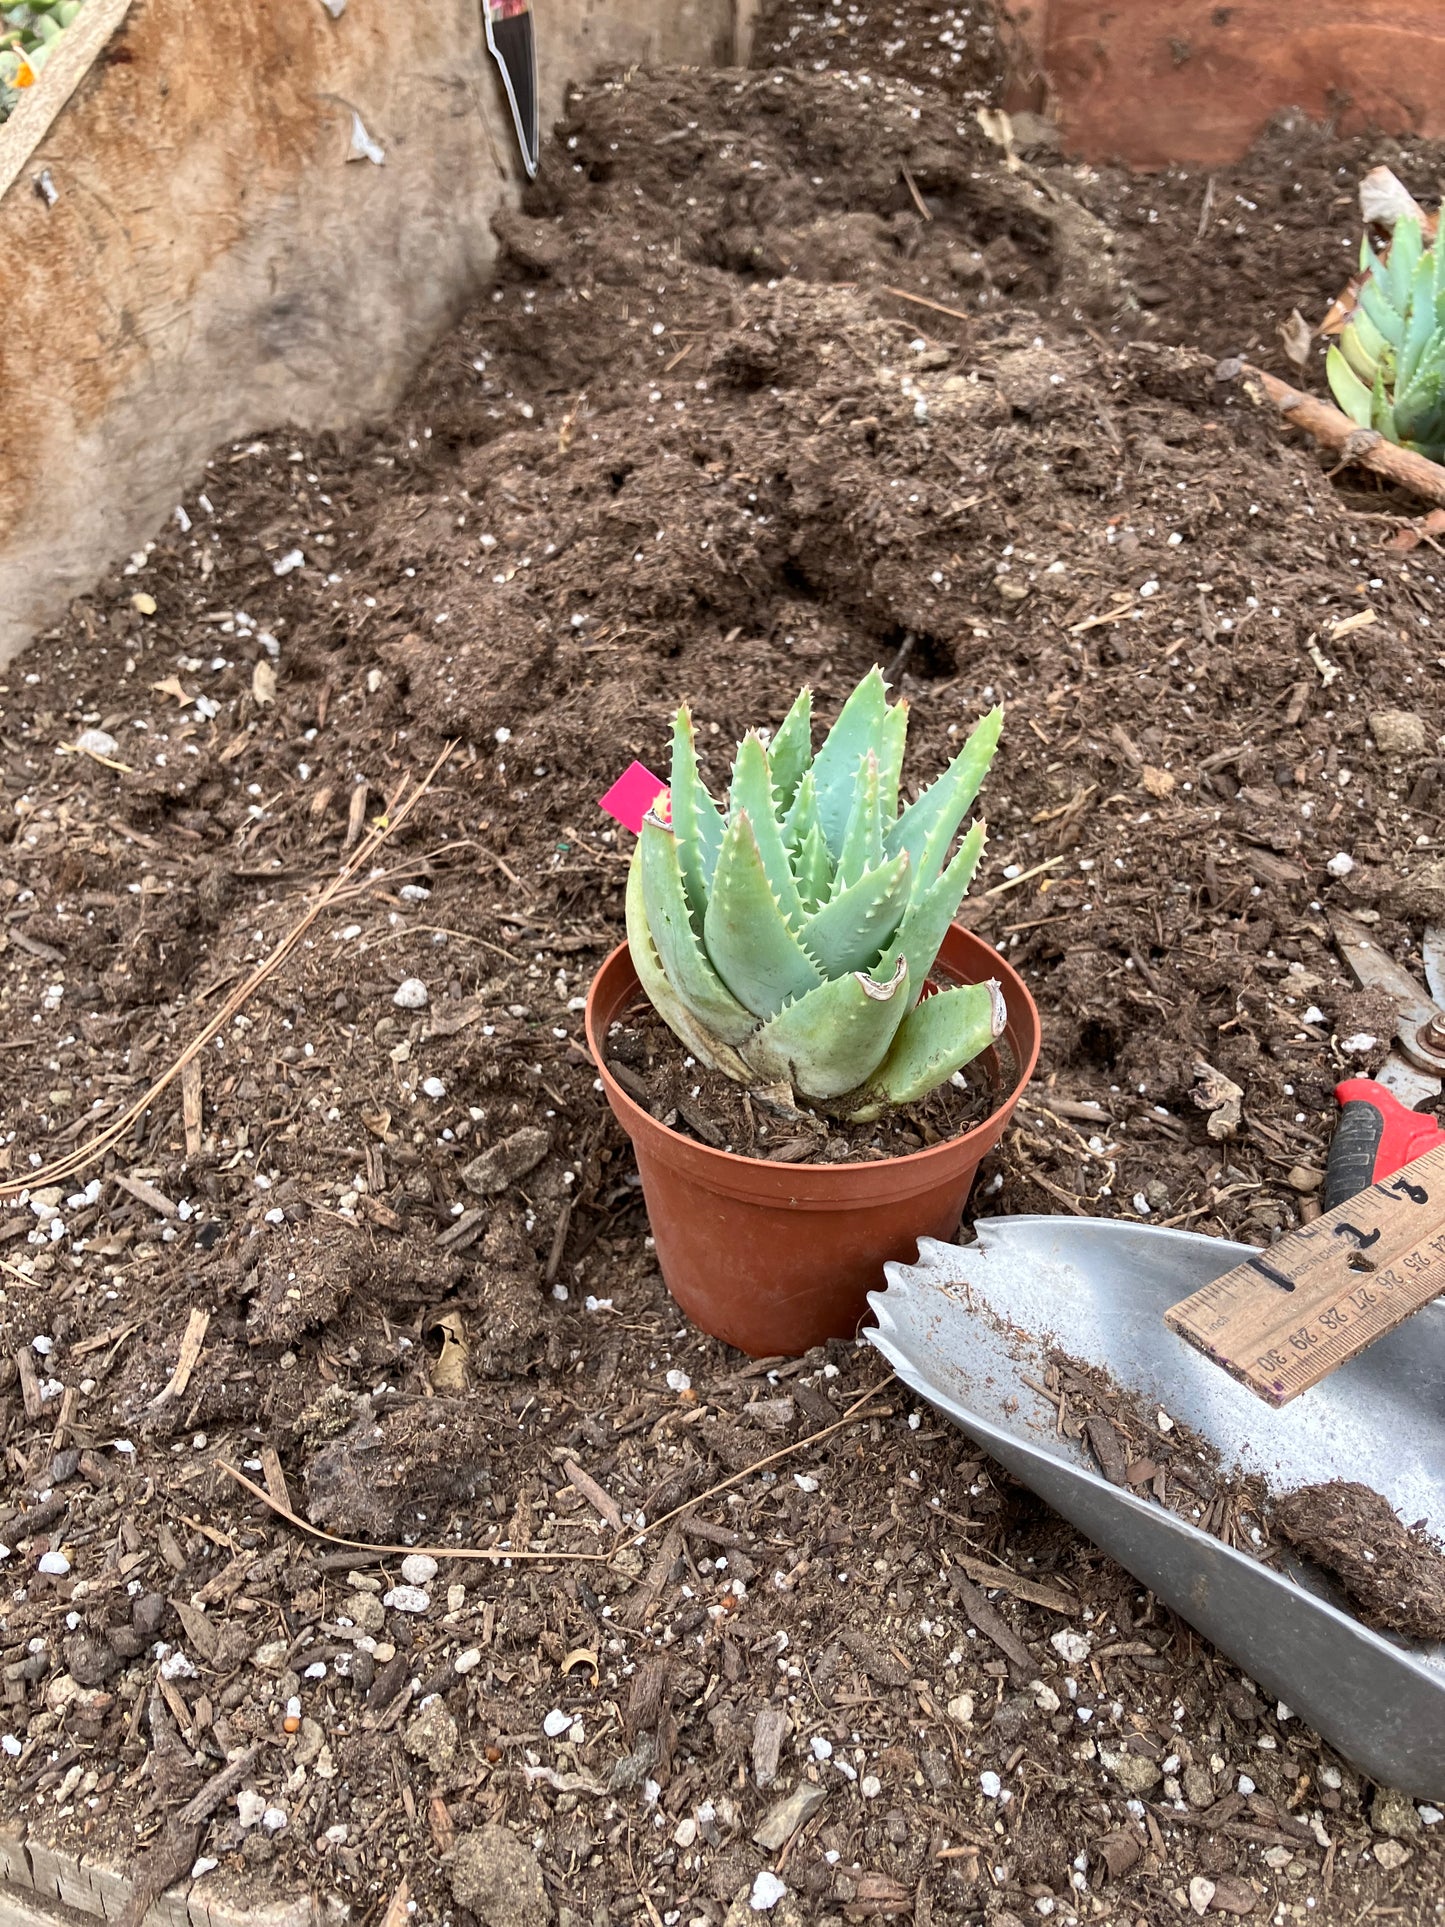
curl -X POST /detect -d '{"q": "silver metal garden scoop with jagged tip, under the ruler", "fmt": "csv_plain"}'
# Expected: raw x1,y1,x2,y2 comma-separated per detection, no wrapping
867,1218,1445,1802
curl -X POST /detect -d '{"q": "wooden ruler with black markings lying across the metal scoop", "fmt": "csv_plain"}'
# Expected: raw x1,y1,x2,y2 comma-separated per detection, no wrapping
1164,1145,1445,1405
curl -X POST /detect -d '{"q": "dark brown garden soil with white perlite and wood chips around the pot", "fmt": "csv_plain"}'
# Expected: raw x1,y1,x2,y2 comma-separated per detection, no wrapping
0,4,1445,1927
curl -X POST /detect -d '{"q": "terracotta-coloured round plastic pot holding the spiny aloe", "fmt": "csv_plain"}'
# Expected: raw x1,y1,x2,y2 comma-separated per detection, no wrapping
588,923,1038,1359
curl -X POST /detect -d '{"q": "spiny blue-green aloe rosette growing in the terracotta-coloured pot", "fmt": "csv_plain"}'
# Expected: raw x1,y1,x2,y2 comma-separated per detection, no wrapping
626,669,1004,1118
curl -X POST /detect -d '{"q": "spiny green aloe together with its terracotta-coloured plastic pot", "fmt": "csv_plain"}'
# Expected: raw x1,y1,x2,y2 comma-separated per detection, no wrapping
588,669,1038,1357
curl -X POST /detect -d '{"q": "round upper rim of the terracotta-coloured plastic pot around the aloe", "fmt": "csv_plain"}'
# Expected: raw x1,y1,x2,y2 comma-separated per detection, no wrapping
584,923,1042,1179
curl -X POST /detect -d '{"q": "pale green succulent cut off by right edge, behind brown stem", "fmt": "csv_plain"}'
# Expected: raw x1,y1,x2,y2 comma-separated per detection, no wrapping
1326,216,1445,462
